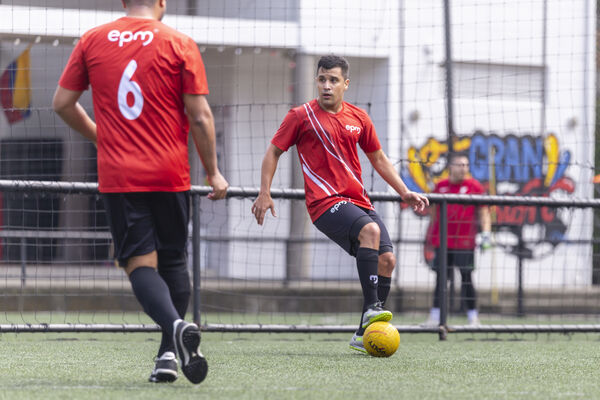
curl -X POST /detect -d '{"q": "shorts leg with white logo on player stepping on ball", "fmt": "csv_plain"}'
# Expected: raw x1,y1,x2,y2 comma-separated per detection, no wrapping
314,200,374,256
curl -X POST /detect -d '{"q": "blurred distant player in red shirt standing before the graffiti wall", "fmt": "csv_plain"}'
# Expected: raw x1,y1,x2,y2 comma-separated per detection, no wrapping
423,153,491,327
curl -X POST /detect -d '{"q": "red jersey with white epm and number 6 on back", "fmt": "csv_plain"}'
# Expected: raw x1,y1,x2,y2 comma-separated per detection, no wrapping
59,17,208,193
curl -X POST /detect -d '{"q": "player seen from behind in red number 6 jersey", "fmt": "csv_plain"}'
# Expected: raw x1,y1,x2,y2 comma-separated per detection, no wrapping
53,0,228,383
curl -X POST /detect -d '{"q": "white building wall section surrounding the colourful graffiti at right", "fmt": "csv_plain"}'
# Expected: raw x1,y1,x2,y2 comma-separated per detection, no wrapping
400,0,595,288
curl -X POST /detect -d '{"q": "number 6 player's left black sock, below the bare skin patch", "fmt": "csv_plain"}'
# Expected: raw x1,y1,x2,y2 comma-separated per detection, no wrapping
129,267,179,335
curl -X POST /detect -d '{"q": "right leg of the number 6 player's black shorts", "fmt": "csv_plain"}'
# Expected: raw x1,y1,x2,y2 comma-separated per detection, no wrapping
151,191,190,253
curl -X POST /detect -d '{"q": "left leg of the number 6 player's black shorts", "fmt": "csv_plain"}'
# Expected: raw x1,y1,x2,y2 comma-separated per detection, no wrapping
102,193,156,267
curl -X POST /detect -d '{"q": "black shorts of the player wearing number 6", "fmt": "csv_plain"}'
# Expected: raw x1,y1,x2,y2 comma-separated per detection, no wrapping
102,191,190,267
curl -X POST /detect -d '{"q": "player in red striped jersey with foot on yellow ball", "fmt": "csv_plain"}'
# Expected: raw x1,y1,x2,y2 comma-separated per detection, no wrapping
252,55,429,353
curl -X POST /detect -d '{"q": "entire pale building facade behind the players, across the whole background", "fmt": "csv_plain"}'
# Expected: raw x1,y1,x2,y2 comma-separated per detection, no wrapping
0,0,595,287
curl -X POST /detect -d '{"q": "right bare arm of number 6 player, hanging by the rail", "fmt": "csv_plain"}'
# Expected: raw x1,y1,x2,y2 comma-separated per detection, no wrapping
183,94,229,200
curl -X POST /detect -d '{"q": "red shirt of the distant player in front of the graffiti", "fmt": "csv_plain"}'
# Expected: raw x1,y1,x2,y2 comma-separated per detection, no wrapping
428,178,485,250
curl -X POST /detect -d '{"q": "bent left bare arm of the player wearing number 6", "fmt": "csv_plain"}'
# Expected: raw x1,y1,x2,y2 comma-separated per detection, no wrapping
52,85,96,144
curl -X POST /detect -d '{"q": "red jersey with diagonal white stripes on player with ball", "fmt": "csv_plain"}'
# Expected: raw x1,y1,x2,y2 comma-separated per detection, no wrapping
271,99,381,222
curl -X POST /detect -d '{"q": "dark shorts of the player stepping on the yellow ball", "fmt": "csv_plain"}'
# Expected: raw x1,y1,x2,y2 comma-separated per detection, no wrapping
315,201,394,256
